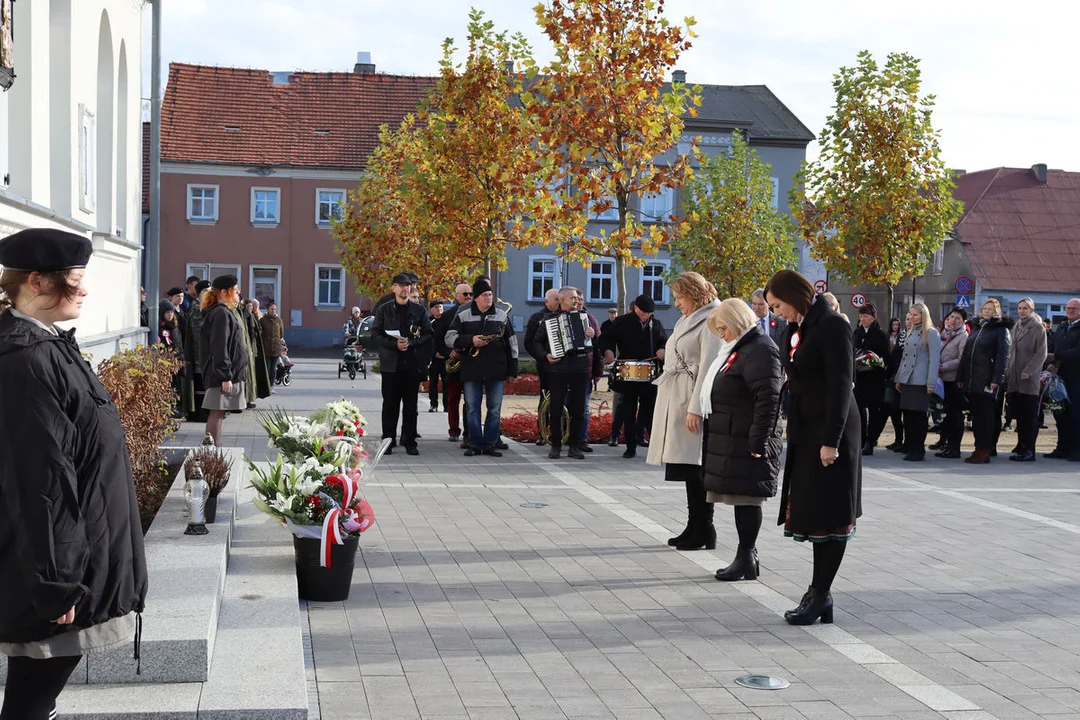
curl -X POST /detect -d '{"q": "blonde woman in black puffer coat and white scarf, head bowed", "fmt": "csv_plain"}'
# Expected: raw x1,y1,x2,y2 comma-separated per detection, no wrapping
699,298,783,581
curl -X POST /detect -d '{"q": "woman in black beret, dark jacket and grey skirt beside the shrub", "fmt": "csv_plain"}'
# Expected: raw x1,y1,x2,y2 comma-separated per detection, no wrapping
199,275,247,446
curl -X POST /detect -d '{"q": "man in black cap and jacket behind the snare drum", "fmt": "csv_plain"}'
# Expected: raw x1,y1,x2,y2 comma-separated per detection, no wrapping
600,295,667,458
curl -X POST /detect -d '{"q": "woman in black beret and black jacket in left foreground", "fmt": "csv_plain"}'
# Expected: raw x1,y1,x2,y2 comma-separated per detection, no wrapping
0,230,147,720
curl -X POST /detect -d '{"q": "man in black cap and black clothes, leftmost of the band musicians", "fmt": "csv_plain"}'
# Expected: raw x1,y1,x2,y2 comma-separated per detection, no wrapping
372,273,432,456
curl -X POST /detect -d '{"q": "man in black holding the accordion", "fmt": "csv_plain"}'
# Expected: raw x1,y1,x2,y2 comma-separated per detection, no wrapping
529,286,596,460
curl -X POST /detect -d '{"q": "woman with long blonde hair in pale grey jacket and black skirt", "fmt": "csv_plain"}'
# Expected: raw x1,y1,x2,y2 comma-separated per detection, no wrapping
896,302,942,461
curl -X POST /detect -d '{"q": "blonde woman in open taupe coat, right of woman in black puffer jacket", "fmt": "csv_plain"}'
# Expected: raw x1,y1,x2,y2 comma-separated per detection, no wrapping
1005,298,1047,462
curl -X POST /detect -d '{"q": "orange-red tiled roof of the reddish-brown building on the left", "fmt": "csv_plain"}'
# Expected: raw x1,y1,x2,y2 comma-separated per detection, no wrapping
161,63,436,169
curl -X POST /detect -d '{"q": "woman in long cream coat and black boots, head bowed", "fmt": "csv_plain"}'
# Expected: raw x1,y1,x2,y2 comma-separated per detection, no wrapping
646,272,720,551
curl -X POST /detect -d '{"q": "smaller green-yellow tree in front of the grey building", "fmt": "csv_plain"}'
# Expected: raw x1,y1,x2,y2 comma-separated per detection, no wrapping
672,131,798,298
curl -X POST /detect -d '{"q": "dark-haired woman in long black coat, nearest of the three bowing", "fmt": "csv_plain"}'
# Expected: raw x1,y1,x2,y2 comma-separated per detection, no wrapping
765,270,863,625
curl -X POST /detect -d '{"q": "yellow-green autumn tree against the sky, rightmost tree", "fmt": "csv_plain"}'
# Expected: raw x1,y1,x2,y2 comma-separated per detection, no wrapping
791,51,962,308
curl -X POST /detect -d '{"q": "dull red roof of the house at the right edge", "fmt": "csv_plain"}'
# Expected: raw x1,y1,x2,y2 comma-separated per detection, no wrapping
955,167,1080,294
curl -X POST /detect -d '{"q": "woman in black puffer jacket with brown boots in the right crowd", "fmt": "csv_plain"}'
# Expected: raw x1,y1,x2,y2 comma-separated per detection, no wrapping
956,298,1013,464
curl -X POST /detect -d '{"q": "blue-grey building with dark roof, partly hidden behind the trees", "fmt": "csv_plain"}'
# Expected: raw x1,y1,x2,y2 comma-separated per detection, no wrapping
495,79,813,354
